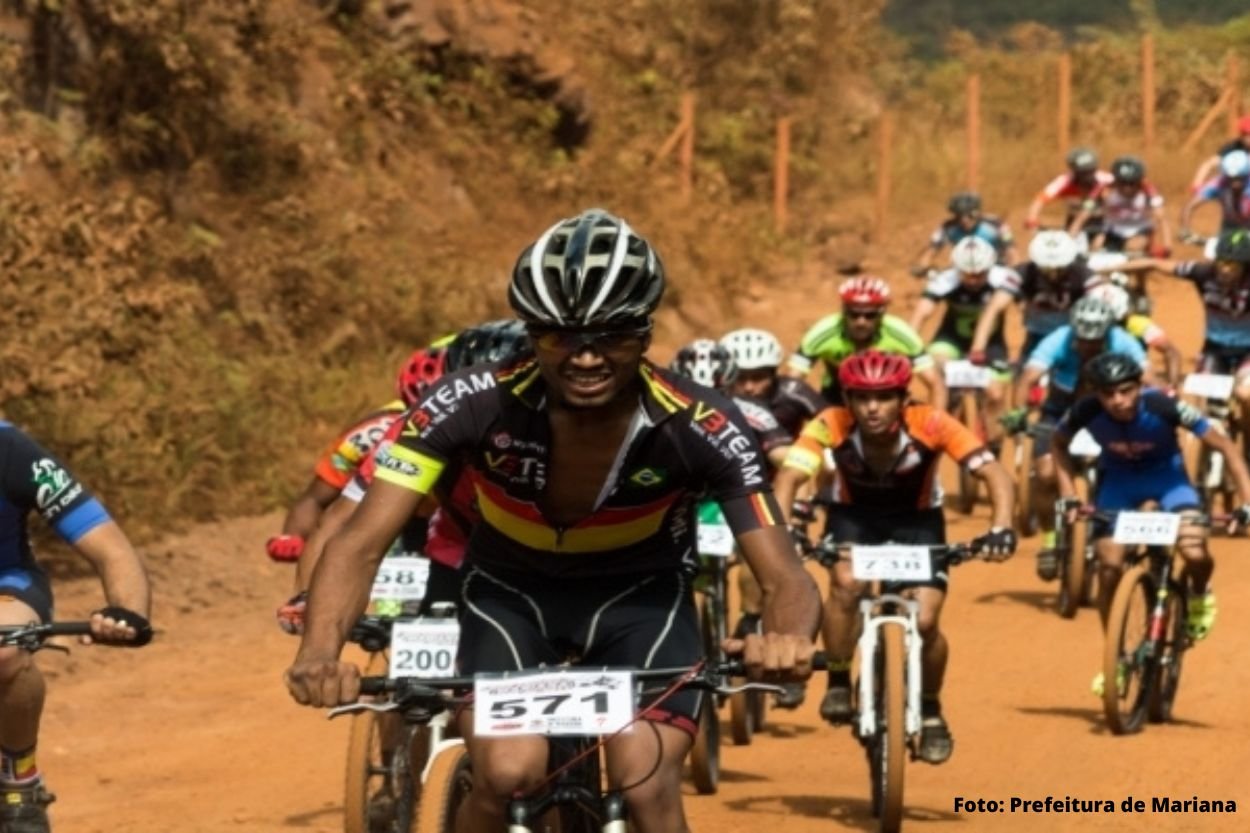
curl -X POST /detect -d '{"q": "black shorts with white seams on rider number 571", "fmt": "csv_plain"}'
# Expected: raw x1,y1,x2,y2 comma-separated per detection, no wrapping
456,567,704,735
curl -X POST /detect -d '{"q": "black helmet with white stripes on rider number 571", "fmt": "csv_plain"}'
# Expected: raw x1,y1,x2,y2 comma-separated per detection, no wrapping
508,209,664,328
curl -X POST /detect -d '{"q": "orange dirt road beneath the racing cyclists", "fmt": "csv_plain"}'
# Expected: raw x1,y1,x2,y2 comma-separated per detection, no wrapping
34,245,1250,833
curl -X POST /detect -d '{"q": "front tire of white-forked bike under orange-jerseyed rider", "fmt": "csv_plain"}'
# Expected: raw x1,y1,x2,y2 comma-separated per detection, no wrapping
873,622,908,833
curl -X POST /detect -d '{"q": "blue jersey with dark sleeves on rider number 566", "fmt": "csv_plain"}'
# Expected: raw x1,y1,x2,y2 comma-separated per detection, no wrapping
1055,389,1211,473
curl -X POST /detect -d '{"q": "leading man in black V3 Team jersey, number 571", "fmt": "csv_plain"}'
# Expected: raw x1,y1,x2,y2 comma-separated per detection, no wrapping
286,210,820,833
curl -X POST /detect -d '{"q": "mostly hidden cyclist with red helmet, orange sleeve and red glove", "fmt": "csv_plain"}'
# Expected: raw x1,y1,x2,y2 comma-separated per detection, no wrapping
265,336,450,562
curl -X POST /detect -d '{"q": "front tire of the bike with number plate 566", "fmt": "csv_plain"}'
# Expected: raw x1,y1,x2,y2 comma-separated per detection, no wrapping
1103,563,1155,734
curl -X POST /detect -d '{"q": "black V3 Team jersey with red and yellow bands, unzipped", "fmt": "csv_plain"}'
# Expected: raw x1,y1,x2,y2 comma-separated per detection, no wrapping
375,359,781,575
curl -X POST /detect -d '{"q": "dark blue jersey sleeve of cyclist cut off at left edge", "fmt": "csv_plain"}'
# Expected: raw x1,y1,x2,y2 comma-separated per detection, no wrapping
0,420,109,572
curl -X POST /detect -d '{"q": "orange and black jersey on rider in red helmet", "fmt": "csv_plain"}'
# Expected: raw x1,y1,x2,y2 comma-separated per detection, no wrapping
784,405,994,513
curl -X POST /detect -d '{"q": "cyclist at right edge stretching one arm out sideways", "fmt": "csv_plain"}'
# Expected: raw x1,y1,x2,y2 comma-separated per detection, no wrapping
1121,230,1250,447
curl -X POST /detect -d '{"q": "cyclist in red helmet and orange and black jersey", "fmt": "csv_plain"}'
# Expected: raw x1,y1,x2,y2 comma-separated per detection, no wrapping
775,350,1016,763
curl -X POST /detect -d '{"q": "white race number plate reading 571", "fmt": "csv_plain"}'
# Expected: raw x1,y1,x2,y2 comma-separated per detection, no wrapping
473,669,634,738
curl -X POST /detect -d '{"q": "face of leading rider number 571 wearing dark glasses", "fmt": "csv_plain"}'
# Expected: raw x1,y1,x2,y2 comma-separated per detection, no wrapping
530,326,651,408
